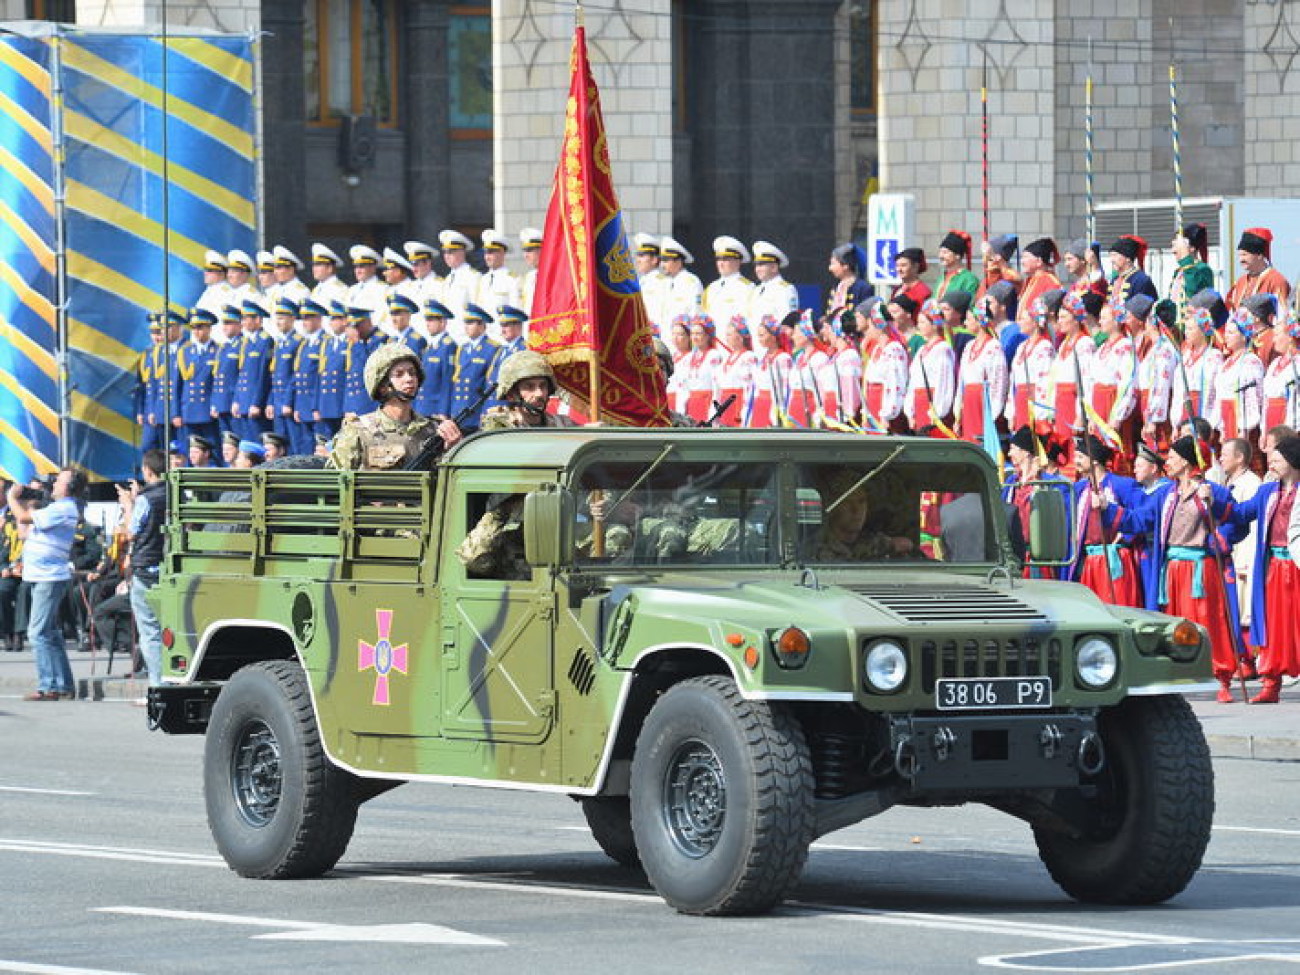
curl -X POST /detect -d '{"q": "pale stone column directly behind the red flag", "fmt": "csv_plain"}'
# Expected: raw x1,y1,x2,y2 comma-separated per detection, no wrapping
493,0,672,261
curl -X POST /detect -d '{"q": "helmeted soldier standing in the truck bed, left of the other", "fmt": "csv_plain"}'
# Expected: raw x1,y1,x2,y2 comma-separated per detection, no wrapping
329,343,460,471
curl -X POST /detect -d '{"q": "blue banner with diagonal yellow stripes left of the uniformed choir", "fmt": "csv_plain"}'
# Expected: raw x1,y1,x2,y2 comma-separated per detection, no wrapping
0,29,257,480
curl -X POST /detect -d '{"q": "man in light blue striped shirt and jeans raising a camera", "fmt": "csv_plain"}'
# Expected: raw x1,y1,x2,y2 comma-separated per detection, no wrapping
8,467,86,701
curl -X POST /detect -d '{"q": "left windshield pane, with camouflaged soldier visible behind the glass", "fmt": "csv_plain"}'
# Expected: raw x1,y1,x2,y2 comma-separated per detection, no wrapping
575,455,779,566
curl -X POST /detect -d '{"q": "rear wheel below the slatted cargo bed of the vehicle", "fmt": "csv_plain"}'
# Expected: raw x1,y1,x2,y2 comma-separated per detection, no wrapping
203,660,358,880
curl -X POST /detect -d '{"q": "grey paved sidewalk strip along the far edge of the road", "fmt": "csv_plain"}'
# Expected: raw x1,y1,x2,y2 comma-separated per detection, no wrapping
0,651,1300,762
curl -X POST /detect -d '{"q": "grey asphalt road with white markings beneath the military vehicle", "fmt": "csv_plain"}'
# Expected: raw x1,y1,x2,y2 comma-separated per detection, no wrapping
0,699,1300,975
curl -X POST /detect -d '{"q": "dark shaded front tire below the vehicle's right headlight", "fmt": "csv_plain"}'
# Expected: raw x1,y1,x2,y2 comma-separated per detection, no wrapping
1034,696,1214,905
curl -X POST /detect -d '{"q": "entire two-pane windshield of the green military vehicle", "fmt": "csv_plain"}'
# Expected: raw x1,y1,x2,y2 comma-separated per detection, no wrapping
573,454,997,566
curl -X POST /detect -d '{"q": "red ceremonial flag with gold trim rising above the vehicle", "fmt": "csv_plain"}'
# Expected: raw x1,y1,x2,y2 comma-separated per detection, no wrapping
528,27,670,426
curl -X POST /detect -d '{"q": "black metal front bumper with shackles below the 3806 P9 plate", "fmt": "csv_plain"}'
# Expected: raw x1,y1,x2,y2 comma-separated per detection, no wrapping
889,711,1105,792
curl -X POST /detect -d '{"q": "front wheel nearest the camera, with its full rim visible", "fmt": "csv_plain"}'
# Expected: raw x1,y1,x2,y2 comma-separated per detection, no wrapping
631,677,815,915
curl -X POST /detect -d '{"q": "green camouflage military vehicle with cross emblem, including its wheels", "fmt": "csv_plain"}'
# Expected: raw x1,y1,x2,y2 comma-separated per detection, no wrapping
150,428,1214,914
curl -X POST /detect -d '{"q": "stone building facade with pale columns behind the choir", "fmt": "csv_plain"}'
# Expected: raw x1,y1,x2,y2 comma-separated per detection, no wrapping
12,0,1300,283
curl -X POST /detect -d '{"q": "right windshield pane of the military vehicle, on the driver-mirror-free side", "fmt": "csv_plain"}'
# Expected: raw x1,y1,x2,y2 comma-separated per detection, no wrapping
794,460,996,566
